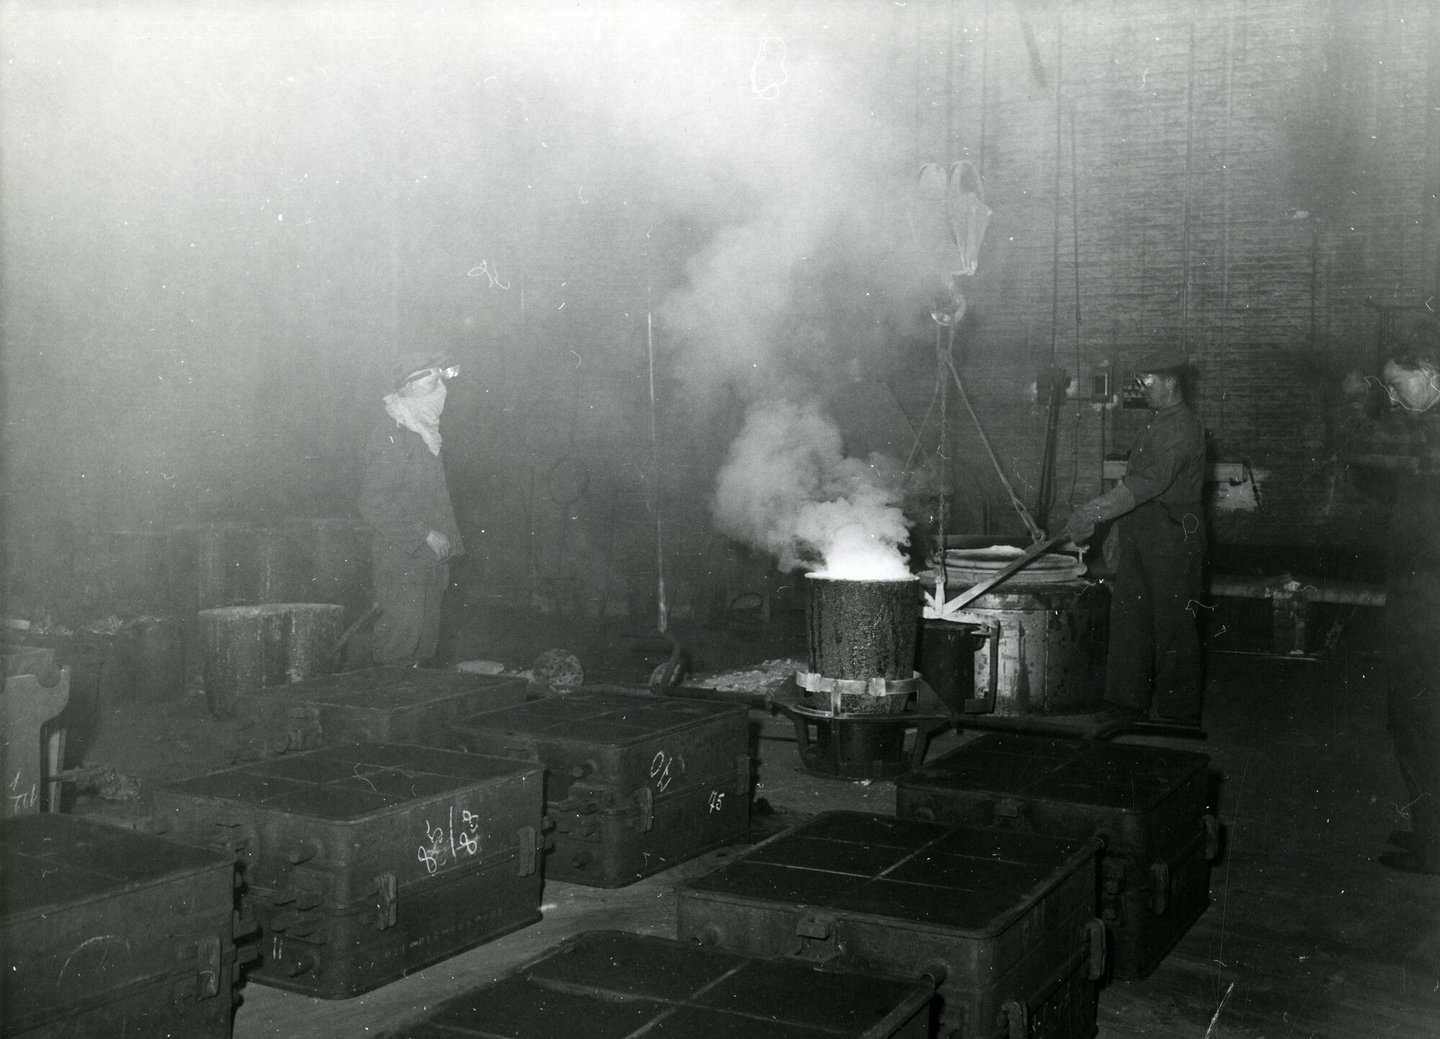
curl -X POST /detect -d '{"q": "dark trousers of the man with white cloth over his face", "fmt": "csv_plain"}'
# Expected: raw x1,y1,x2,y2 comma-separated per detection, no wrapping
370,541,449,663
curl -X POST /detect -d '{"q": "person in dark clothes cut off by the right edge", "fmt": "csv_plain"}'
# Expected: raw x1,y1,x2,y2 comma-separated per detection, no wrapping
1345,321,1440,874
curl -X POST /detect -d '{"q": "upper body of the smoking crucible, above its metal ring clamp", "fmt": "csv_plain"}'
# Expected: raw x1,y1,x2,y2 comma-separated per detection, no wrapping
805,574,920,681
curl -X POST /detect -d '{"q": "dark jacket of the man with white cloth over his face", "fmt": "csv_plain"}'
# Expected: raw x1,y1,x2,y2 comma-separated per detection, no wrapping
360,414,465,555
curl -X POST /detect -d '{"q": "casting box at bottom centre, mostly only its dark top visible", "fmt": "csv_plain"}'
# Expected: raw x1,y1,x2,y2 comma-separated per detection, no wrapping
377,931,933,1039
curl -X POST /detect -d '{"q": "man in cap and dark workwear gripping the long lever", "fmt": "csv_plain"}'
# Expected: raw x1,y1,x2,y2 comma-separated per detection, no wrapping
1066,358,1205,727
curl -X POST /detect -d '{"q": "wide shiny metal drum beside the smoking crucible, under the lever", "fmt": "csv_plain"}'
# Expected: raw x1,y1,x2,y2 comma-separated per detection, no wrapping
966,580,1110,717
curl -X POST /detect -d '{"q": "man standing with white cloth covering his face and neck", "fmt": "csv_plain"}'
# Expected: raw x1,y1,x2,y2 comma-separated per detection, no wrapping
360,354,465,665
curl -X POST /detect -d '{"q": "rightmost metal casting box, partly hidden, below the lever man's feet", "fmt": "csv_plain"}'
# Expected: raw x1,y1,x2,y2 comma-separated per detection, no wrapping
896,732,1220,979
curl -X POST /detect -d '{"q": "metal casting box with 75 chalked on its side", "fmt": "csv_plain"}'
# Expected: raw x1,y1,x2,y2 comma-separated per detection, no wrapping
454,689,750,888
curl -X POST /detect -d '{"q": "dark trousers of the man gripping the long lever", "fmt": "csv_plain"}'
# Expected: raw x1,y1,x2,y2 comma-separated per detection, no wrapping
1104,502,1205,722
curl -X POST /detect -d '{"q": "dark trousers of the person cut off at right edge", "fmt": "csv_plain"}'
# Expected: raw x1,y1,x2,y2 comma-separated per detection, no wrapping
1385,570,1440,869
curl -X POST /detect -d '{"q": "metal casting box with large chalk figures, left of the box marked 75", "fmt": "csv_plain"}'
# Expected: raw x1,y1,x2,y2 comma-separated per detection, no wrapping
156,744,543,999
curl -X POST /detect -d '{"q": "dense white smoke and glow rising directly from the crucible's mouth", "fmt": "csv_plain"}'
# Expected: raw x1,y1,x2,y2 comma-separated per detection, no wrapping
711,401,910,580
